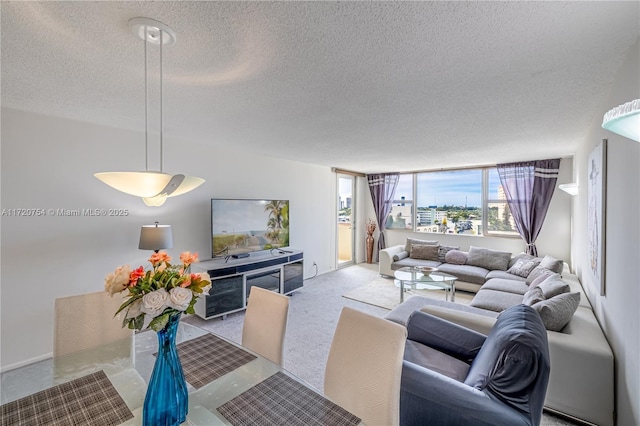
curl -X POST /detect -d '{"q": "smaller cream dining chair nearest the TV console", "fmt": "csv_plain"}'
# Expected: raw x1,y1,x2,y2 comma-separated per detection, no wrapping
242,286,289,365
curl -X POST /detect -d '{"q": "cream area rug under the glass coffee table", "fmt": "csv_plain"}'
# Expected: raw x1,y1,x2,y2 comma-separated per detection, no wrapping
342,277,474,310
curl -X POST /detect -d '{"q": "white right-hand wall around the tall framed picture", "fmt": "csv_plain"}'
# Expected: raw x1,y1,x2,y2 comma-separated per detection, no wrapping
572,39,640,425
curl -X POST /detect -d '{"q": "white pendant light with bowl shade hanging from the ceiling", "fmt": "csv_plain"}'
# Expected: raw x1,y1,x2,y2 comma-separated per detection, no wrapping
94,18,204,206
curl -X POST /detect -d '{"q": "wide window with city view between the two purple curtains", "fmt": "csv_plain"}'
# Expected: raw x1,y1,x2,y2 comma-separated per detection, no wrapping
385,167,519,236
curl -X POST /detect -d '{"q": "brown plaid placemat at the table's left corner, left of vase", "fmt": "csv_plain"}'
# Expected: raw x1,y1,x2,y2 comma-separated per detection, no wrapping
2,370,133,426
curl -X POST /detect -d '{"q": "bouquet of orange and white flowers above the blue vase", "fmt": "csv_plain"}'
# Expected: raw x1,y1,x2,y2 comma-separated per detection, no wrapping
104,251,211,331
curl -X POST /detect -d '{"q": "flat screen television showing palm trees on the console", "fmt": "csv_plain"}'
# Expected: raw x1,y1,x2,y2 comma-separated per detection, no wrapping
211,198,289,257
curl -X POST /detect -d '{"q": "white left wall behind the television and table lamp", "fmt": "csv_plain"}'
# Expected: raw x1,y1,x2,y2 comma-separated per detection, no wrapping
0,108,336,369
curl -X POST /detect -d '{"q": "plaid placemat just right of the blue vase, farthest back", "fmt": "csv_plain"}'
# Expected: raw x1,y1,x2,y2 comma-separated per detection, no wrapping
177,334,256,389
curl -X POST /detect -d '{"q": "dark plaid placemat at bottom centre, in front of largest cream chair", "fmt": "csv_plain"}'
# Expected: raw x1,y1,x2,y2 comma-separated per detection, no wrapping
218,372,361,426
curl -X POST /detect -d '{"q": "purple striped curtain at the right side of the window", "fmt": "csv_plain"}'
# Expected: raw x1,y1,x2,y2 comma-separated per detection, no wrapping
497,159,560,256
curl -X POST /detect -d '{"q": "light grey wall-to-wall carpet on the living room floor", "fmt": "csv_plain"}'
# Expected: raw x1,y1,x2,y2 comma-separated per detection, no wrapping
182,263,576,426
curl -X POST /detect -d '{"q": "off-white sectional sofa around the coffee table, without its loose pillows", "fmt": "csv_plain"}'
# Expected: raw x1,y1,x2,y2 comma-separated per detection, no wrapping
380,241,615,426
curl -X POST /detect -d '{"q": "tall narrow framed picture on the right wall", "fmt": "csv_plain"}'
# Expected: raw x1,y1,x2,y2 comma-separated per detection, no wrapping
587,139,607,296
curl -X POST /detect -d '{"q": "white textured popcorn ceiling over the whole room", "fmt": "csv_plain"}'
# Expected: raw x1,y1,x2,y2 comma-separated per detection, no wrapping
0,1,640,173
